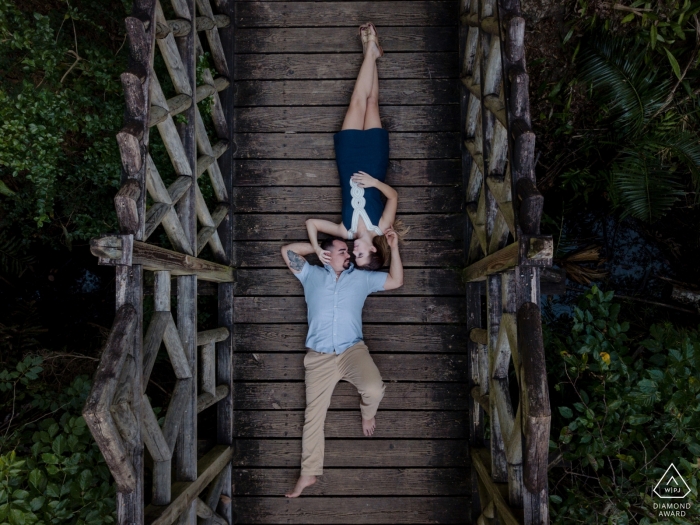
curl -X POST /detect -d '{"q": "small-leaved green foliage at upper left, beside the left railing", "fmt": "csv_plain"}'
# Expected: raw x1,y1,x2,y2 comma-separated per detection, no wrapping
0,0,126,247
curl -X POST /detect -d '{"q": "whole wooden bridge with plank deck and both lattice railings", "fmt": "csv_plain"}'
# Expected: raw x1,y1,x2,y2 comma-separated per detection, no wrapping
84,0,551,524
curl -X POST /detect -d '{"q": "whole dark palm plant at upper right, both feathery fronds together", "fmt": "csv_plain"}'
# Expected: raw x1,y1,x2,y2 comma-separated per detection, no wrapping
579,35,700,222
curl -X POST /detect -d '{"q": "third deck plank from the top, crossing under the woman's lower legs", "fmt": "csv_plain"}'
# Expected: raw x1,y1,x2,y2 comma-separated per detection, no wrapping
234,53,459,80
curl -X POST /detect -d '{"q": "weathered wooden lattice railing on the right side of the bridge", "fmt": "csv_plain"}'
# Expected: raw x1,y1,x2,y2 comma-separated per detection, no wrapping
460,0,552,525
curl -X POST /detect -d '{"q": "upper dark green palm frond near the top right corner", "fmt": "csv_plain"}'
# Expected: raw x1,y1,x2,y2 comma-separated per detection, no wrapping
579,35,670,135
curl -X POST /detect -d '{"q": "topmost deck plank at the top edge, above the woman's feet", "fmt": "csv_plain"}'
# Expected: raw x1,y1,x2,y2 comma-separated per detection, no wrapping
236,1,459,28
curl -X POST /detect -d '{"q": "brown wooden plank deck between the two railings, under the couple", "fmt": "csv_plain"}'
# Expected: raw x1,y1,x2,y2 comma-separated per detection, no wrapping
233,0,471,524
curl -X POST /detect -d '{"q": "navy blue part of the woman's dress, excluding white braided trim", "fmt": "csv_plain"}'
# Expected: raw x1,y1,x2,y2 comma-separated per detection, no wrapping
333,128,389,230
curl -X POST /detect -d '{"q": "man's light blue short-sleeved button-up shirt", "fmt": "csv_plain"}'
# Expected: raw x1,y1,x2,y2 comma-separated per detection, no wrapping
294,263,389,354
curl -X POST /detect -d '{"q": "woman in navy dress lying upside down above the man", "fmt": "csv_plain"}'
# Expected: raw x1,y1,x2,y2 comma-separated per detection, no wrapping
306,22,406,271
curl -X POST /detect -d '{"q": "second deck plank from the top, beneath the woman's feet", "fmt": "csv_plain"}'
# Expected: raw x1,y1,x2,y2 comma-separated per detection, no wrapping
236,27,457,53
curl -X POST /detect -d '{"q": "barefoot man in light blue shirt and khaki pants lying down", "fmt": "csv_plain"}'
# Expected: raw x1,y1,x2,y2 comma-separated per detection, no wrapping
282,228,403,498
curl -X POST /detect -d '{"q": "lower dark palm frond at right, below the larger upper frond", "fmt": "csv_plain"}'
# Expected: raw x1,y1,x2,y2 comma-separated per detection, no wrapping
611,146,684,223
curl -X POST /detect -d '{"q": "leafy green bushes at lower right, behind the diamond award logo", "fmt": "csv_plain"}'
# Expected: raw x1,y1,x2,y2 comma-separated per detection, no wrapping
546,287,700,525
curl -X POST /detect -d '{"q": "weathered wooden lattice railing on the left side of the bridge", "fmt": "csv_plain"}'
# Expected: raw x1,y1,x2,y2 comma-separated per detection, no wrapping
83,0,233,525
